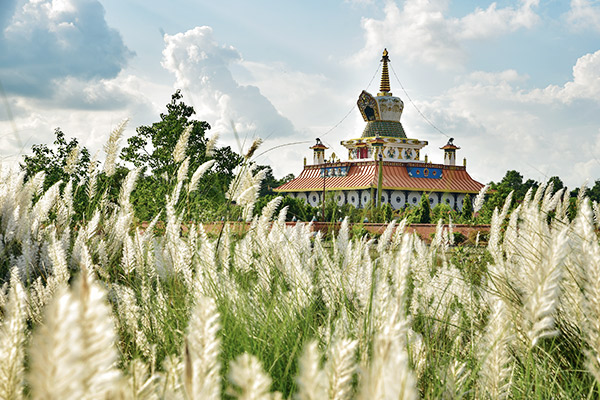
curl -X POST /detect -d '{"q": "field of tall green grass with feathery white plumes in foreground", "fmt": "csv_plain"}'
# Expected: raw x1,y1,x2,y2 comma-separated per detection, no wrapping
0,134,600,400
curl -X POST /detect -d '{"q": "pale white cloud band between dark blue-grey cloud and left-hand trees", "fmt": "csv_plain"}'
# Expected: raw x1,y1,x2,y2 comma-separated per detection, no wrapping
0,73,172,169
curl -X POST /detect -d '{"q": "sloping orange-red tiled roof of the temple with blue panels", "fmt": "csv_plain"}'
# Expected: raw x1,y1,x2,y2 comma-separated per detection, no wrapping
275,161,483,193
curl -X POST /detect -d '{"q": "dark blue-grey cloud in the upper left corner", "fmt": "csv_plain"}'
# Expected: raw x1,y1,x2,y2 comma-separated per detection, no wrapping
0,0,133,98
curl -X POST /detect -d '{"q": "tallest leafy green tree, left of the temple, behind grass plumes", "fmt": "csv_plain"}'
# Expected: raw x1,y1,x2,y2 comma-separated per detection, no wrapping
121,90,242,220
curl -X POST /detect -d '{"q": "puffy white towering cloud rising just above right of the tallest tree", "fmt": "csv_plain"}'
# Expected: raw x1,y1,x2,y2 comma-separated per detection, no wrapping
162,26,294,138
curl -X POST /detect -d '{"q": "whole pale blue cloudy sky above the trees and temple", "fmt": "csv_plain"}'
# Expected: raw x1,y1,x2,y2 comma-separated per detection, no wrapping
0,0,600,188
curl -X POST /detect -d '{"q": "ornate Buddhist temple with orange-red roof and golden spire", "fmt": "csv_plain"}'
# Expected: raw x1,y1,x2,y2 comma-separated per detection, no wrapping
275,50,483,210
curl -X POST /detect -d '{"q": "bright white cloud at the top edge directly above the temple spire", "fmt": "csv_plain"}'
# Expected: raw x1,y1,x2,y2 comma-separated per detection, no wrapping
353,0,539,69
